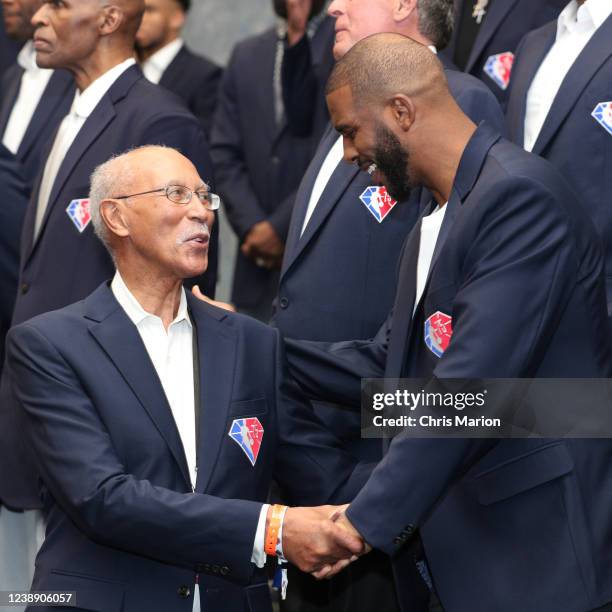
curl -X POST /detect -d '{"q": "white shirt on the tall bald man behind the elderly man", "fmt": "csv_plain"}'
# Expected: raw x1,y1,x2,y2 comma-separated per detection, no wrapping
34,57,136,238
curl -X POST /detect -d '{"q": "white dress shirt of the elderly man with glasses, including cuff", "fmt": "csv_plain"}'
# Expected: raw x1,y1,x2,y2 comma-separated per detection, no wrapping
111,271,268,612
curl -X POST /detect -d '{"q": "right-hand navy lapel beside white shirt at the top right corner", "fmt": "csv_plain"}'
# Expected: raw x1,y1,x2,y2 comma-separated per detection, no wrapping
533,16,612,155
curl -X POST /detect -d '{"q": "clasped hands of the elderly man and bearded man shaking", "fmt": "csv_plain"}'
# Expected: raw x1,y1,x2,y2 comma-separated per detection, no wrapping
274,505,371,579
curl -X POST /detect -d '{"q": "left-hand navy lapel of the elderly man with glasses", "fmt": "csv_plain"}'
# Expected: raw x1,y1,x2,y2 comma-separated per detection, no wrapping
86,284,191,488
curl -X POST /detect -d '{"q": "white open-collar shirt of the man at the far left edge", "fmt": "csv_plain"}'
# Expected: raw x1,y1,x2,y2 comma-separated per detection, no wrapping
2,40,53,155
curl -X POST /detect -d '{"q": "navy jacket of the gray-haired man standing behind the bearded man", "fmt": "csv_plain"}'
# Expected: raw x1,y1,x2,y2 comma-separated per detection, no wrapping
272,70,503,457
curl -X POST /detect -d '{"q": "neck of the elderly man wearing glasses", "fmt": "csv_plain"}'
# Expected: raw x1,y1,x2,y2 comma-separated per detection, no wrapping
117,262,183,330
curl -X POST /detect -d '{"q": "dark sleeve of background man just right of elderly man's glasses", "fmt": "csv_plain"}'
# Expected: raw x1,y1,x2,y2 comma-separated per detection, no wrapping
211,49,267,240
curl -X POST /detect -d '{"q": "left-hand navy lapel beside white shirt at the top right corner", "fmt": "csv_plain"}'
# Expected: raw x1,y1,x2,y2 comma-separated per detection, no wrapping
508,22,557,146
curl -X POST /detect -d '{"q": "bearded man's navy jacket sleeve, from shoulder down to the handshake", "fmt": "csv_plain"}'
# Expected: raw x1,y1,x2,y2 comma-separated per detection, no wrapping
348,177,580,554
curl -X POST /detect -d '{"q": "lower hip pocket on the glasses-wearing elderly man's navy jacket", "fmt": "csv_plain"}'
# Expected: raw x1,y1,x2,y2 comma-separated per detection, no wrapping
43,570,125,612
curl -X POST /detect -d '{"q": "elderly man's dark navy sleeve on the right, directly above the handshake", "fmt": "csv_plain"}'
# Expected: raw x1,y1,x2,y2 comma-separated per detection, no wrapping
275,331,373,506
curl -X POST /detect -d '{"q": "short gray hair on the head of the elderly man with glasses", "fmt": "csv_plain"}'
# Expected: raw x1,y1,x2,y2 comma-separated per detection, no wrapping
89,145,174,259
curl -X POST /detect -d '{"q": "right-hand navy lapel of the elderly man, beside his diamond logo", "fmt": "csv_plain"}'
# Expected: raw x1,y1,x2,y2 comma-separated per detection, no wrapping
187,294,237,493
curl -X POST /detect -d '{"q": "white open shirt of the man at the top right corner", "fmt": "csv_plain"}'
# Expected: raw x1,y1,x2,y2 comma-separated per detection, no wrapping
523,0,612,151
